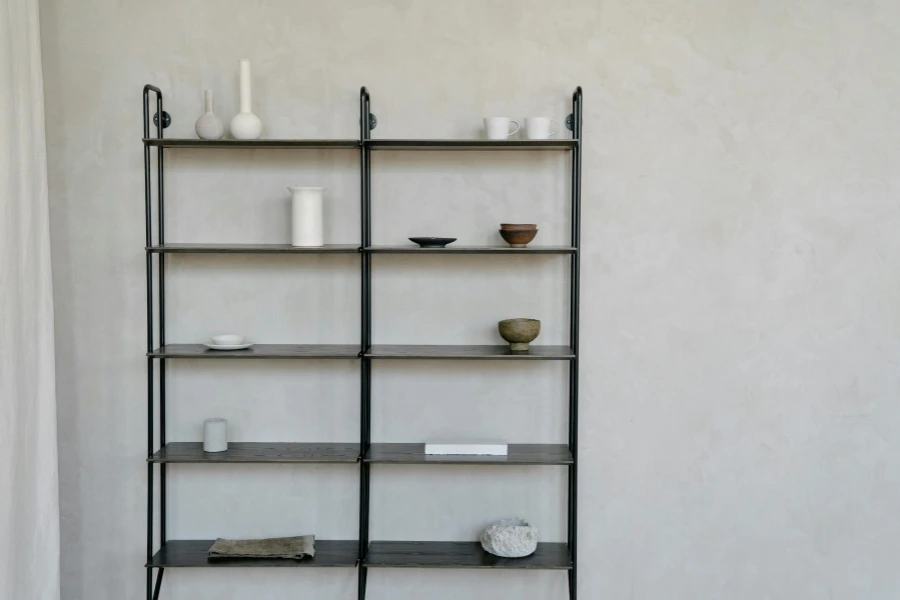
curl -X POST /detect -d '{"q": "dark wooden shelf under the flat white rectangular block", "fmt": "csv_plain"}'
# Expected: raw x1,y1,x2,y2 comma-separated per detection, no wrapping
364,444,574,465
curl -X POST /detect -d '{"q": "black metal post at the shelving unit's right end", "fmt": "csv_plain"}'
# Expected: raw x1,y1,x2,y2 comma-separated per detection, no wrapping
568,86,582,600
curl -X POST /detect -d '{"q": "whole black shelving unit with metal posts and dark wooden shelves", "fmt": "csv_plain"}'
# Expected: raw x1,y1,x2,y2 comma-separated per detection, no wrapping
143,85,582,600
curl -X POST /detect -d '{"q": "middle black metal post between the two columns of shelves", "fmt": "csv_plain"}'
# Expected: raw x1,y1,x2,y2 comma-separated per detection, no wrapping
357,88,372,600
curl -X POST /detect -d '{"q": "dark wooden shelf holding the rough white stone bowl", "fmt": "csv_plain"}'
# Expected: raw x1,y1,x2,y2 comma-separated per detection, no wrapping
363,542,572,569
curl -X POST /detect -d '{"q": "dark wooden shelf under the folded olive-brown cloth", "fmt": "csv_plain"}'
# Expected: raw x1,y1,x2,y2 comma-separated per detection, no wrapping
144,540,359,568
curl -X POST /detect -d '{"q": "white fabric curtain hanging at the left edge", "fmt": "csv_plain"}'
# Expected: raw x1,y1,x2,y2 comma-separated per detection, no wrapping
0,0,59,600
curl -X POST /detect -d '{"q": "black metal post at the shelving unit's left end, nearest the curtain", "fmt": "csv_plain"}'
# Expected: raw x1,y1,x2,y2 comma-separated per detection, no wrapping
144,85,162,600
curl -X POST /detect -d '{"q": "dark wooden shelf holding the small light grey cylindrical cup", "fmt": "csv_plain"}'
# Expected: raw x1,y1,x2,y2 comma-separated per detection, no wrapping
147,442,359,463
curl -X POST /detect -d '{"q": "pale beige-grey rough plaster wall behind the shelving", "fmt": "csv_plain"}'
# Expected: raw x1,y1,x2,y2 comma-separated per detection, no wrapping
41,0,900,600
